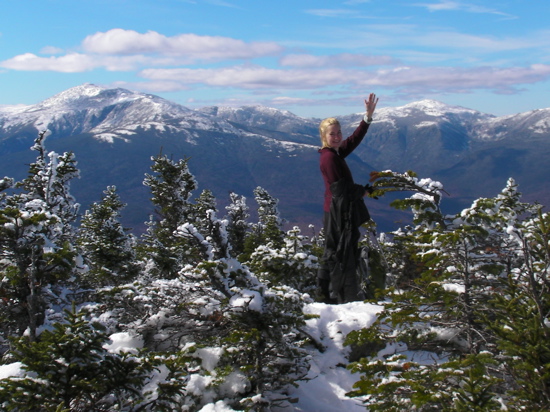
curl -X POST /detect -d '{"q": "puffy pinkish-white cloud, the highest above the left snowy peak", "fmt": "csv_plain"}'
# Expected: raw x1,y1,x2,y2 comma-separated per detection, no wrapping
82,29,283,61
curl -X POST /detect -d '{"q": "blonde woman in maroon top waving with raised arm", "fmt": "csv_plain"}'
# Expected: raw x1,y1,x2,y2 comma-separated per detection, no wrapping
318,93,378,303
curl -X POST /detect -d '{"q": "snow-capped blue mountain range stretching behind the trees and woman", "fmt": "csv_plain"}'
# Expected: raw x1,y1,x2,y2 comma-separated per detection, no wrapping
0,84,550,232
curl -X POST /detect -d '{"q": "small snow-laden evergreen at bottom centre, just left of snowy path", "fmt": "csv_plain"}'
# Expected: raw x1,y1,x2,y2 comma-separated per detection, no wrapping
215,286,310,411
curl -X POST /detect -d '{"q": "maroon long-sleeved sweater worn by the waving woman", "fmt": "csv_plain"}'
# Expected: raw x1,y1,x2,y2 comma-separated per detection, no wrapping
319,120,369,212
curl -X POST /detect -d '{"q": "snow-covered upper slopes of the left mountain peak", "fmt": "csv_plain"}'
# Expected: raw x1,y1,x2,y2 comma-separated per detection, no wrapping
0,84,248,141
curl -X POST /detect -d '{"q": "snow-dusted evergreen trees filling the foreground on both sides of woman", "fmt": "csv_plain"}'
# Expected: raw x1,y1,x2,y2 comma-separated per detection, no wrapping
0,134,550,411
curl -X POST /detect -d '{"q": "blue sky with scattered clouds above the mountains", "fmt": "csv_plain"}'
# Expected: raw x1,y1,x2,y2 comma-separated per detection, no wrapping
0,0,550,117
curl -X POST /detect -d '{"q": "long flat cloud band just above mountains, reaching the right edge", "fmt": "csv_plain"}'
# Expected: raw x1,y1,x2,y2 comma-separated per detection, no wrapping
140,64,550,93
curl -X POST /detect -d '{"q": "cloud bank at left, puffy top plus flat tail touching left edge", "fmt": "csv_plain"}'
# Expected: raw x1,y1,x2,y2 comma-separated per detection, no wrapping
0,29,283,73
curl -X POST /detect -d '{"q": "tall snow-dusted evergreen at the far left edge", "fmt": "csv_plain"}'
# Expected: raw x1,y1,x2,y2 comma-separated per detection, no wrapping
0,132,79,340
